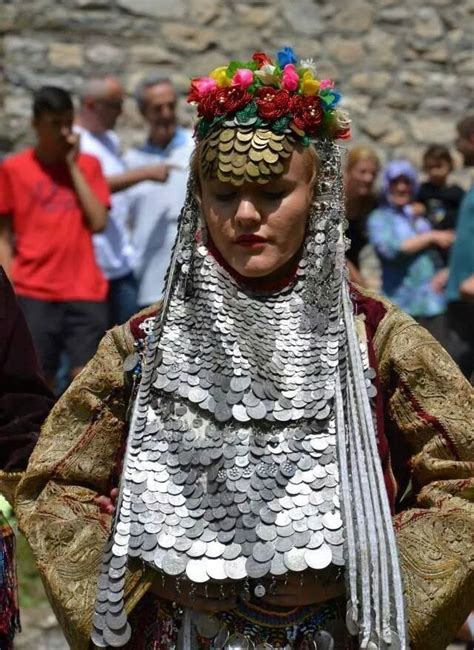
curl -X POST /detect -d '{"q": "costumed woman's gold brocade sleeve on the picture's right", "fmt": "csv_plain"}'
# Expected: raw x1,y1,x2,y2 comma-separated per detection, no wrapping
374,308,474,650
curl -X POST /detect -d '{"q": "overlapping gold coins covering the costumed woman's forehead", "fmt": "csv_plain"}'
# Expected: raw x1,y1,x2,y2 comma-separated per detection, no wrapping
200,128,296,186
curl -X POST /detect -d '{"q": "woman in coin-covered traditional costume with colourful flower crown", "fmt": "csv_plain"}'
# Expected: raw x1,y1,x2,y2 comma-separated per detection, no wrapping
17,48,474,650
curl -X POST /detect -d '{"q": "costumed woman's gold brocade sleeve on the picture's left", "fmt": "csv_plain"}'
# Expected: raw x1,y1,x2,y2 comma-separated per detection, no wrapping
16,326,149,650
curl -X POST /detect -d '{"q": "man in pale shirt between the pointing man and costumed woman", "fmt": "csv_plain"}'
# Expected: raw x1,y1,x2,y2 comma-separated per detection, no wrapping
125,76,194,307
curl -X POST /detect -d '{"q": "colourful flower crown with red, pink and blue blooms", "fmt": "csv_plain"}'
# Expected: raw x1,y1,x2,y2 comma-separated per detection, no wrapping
188,47,351,145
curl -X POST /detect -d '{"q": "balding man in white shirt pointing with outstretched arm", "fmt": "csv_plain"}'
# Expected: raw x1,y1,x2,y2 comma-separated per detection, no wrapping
75,76,173,325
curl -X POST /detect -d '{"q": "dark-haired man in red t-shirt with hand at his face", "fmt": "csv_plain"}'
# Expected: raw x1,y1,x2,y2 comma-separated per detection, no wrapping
0,86,109,385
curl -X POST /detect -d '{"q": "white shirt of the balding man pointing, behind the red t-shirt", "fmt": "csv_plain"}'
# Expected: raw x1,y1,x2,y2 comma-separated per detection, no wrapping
74,126,133,280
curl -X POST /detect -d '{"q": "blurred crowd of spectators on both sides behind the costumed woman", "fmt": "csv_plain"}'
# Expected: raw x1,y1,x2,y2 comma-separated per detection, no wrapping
0,75,474,392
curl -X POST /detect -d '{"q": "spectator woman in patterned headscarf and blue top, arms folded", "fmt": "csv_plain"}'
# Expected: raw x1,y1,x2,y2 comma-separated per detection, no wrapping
368,160,454,342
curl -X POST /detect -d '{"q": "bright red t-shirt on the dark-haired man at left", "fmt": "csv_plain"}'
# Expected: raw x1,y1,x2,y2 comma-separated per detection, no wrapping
0,148,110,302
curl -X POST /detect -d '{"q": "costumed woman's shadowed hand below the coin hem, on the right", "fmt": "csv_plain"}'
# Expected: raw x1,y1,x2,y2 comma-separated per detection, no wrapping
261,571,345,607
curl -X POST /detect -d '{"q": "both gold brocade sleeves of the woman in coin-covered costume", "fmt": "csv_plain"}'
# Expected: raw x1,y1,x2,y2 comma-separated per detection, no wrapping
12,298,474,650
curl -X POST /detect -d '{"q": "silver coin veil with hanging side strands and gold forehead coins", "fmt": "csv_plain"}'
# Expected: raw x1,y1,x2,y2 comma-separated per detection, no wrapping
93,49,404,647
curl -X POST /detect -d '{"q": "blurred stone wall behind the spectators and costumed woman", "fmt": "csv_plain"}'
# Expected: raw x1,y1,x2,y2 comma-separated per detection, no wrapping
0,0,474,170
